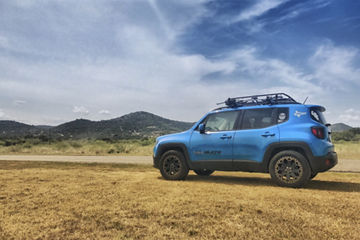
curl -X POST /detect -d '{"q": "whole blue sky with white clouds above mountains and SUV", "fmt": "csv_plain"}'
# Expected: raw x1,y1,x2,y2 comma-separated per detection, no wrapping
0,0,360,127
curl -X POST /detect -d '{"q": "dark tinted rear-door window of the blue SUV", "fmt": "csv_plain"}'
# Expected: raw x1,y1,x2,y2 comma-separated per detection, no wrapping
241,108,277,129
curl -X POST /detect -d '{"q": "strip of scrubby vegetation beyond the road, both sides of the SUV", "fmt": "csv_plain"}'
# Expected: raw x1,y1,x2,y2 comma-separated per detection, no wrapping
0,128,360,160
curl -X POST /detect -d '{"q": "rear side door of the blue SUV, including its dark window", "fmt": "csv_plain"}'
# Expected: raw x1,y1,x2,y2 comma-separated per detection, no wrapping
233,107,279,169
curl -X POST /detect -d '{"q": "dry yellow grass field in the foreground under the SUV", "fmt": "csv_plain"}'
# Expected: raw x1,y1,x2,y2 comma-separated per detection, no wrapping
0,162,360,239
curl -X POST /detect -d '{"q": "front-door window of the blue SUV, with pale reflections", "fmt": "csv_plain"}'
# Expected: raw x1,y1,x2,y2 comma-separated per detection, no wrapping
204,111,239,132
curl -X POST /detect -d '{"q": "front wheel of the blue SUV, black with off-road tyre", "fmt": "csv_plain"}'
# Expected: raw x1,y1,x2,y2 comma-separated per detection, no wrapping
160,150,189,180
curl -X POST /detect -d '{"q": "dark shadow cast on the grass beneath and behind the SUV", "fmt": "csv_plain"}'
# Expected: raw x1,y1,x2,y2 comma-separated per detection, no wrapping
181,175,360,192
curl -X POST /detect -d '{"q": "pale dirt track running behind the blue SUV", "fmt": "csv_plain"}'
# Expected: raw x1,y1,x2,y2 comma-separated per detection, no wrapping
0,155,360,172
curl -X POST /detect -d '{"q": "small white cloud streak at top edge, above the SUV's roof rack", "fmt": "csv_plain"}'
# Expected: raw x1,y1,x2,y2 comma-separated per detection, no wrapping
232,0,288,22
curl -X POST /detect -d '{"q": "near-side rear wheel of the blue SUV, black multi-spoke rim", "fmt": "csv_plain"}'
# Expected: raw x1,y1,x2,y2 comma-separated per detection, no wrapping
269,150,311,187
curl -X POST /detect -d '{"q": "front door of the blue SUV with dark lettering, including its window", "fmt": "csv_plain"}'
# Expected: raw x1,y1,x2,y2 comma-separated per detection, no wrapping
190,111,239,170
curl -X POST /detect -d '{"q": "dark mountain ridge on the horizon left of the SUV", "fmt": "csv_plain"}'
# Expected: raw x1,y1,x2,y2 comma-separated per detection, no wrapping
0,111,193,139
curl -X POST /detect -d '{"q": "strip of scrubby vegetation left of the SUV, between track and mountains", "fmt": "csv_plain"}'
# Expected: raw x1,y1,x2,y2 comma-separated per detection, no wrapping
0,138,155,155
